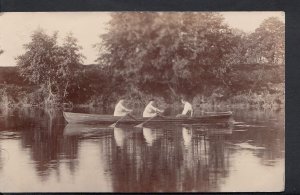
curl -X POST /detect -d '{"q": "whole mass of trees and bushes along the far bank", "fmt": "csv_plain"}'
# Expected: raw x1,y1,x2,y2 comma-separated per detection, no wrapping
0,12,284,111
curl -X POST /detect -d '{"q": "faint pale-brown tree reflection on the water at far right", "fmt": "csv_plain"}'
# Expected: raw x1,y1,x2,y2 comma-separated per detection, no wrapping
228,110,285,164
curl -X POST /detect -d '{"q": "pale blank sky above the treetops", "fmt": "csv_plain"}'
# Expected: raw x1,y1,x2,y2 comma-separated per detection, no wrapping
0,12,285,66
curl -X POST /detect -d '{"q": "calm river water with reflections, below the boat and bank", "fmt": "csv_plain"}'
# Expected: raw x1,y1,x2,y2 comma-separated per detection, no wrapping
0,106,285,192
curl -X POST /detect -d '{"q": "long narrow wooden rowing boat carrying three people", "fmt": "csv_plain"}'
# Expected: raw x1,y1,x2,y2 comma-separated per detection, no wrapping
63,111,232,125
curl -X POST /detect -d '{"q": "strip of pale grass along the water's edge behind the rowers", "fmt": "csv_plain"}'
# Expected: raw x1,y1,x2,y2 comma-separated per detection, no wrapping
0,86,284,112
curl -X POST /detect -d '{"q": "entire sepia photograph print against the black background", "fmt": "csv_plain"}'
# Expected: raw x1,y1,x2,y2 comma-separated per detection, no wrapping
0,11,285,193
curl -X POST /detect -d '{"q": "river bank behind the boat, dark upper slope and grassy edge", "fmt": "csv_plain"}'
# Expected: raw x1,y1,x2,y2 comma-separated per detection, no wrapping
0,65,285,113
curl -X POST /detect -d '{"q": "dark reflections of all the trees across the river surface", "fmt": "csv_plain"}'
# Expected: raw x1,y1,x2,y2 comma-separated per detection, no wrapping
0,106,284,192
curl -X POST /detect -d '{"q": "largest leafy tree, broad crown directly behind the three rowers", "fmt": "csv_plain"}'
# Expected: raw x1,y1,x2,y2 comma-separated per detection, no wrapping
97,12,236,100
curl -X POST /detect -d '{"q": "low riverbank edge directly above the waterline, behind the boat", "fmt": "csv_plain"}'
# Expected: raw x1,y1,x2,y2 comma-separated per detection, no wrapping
0,92,284,111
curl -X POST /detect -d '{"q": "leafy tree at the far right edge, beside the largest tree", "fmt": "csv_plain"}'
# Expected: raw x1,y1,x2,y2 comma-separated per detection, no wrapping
227,17,284,93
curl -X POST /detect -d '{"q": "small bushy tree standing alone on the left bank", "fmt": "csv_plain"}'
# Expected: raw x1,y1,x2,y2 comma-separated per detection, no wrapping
17,29,83,104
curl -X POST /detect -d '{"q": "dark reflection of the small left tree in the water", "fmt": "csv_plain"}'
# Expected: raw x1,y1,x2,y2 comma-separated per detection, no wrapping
4,109,78,179
